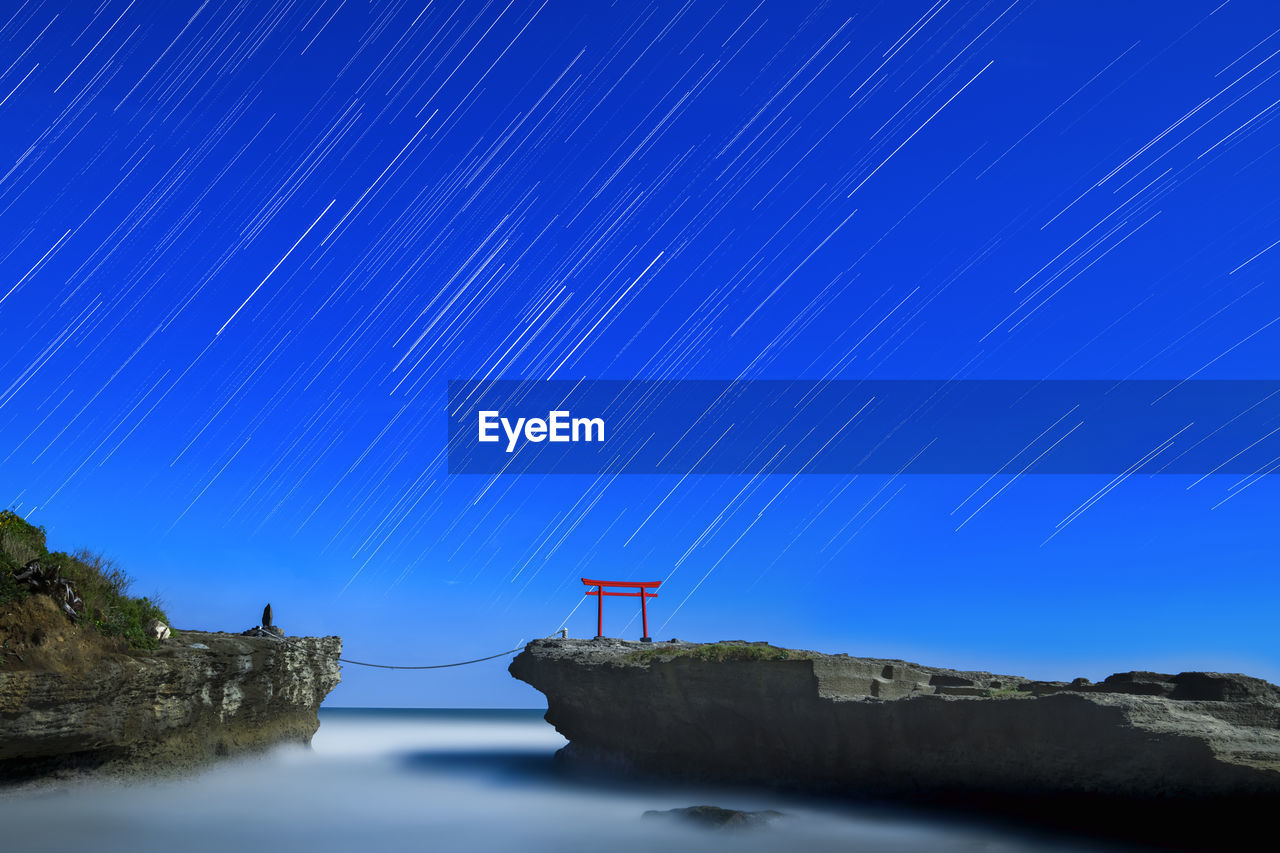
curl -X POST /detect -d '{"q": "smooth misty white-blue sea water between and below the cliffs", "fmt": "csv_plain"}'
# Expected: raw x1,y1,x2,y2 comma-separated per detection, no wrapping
0,708,1121,853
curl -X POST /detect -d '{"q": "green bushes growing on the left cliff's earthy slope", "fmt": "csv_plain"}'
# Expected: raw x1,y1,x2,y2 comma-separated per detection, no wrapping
0,510,169,648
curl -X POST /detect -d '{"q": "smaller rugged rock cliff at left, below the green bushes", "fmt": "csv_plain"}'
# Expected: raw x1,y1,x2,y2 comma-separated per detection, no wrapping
0,631,342,783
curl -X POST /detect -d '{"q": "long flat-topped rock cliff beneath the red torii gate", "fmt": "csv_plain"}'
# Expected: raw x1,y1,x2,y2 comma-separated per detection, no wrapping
509,639,1280,849
